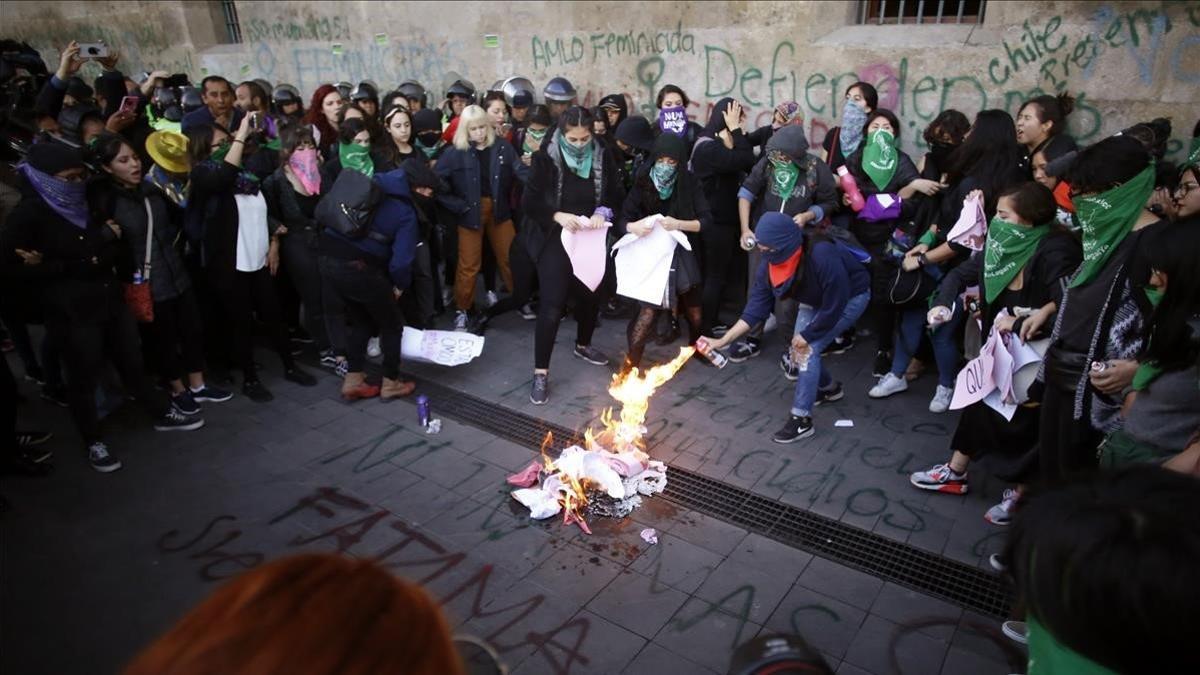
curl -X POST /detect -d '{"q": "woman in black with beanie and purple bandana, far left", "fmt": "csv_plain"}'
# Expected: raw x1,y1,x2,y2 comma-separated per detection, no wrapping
0,143,204,473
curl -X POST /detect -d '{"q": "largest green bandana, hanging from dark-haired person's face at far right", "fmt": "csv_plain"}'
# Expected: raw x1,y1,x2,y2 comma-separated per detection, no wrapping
1070,162,1154,288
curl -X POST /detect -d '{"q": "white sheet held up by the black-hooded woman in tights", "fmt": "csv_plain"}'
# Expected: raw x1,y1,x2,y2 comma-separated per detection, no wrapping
612,214,691,307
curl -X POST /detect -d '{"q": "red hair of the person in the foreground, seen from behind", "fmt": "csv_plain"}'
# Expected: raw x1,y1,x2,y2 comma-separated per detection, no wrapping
125,554,463,675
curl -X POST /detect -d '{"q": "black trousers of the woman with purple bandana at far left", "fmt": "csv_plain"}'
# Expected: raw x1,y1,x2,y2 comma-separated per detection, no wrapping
47,297,167,447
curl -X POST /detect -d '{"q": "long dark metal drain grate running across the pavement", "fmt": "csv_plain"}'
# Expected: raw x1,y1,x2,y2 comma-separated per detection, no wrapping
404,374,1012,617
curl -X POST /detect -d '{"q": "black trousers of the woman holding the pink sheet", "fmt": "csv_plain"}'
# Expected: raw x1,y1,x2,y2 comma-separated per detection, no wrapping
533,235,612,369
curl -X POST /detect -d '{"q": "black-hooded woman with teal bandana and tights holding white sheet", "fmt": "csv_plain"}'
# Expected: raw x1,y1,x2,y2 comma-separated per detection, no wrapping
616,133,713,371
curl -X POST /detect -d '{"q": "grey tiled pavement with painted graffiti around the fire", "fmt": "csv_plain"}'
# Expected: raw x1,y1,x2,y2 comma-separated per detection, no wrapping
0,315,1020,675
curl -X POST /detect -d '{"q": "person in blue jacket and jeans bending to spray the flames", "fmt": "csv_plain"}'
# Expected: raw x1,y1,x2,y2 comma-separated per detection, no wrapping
712,211,871,443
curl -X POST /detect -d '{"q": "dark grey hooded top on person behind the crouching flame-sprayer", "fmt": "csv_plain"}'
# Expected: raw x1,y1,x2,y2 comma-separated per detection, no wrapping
738,126,838,223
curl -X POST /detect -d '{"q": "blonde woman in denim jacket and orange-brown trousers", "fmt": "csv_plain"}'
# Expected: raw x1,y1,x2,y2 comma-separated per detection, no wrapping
434,106,528,330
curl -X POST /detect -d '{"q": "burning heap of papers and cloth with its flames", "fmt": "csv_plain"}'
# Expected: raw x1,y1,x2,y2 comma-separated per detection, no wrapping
509,347,696,534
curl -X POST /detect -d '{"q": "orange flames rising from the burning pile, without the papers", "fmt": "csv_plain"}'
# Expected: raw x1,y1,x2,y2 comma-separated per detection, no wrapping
540,347,696,534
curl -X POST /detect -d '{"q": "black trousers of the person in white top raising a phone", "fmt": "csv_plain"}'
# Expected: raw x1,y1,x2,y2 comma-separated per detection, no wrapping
218,267,295,381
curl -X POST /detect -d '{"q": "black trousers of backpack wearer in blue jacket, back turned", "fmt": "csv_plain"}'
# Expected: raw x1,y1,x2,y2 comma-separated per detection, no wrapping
319,256,404,380
